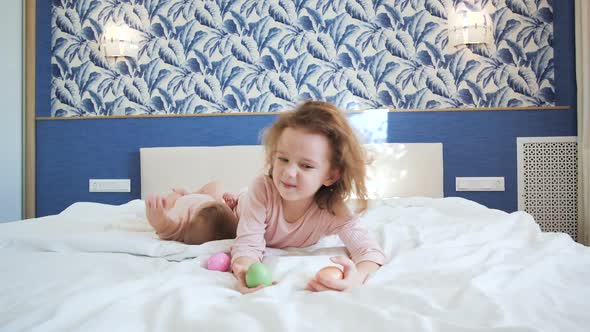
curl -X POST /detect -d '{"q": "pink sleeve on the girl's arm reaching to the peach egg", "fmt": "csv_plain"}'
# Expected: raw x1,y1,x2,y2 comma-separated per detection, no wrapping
337,218,385,265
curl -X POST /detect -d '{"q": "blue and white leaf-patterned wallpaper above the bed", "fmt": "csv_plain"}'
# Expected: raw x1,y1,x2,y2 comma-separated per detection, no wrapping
51,0,555,117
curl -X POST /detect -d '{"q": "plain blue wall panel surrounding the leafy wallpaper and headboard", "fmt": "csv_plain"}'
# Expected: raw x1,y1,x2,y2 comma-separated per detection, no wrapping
36,0,576,216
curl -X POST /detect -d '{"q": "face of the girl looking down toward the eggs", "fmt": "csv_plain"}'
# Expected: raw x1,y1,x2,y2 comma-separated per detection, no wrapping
272,128,338,201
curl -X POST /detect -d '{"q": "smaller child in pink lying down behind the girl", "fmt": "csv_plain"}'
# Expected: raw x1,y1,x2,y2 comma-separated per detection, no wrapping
145,182,238,244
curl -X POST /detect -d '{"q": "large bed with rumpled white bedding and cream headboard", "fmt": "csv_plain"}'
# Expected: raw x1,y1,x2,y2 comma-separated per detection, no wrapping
0,143,590,332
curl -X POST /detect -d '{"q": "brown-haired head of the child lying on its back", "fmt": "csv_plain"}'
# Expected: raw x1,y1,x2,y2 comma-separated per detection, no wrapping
184,201,238,244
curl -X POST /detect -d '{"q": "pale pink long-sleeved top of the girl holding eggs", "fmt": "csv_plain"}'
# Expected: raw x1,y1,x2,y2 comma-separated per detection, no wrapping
231,176,385,265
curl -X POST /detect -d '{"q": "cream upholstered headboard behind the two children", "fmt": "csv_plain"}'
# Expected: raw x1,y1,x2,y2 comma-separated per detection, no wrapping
140,143,443,198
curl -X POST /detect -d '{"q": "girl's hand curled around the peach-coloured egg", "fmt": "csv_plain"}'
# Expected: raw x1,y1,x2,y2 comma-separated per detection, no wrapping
305,256,365,292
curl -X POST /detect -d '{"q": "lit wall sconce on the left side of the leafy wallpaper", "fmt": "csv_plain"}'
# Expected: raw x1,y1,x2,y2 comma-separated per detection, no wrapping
101,25,141,58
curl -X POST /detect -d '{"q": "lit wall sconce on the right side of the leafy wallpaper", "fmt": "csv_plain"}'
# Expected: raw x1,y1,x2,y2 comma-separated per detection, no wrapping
449,11,494,46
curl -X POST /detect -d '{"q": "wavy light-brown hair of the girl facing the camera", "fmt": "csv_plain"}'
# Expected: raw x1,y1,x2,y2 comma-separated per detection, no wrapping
263,101,367,213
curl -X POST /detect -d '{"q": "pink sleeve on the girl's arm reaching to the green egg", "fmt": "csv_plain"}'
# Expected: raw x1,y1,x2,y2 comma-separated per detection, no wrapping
231,176,270,262
